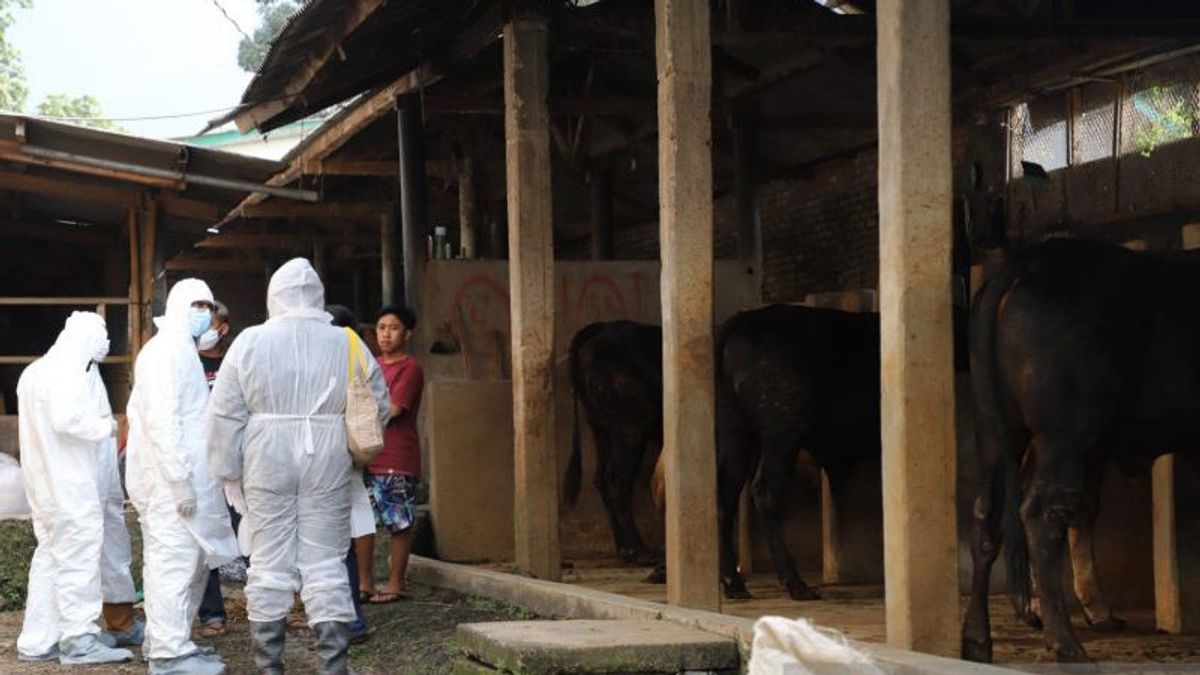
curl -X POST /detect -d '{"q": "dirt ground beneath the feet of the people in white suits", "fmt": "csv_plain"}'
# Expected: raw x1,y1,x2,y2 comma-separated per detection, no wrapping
0,585,534,675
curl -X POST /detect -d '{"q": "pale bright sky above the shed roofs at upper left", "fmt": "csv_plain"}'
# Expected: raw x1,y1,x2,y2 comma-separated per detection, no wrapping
10,0,258,138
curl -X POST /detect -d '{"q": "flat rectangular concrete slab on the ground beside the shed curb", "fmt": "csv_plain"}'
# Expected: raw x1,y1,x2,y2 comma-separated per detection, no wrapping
455,620,738,675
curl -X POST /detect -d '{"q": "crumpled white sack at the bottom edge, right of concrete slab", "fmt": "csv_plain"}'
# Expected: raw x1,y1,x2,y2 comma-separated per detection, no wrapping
748,616,884,675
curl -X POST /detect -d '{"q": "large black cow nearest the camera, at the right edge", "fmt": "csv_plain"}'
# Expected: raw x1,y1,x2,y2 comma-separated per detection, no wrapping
962,240,1200,662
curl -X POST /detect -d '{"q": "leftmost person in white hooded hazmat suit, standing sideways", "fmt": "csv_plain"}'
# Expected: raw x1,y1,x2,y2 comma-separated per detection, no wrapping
17,312,138,664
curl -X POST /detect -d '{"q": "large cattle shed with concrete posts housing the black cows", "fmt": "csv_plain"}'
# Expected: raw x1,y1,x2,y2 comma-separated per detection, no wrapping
11,0,1200,661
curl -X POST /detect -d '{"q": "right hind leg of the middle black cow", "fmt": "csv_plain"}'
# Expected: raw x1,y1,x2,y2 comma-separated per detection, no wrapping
752,438,820,601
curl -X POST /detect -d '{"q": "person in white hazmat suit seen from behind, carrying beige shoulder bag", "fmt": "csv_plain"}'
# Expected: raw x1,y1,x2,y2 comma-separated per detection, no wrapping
209,258,389,674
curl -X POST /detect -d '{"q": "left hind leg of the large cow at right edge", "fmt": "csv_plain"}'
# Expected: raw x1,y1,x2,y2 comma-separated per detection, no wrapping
962,429,1006,663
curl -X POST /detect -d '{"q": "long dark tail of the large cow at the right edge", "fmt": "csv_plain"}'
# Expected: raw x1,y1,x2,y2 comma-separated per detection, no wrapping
971,262,1033,613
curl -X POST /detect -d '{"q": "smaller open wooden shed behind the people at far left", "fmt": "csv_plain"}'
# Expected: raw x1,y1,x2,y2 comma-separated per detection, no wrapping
0,115,297,427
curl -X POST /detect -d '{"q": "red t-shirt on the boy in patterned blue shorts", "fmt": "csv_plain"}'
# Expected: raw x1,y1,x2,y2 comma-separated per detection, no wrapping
367,357,425,478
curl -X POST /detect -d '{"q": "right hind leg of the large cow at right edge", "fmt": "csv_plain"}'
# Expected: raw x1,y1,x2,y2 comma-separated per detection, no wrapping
1021,441,1087,663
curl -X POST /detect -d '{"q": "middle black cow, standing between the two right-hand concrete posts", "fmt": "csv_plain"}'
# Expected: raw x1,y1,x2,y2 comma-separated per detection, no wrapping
716,305,880,599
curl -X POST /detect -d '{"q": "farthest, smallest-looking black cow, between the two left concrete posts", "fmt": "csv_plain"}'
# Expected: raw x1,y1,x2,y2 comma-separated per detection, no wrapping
564,321,662,565
